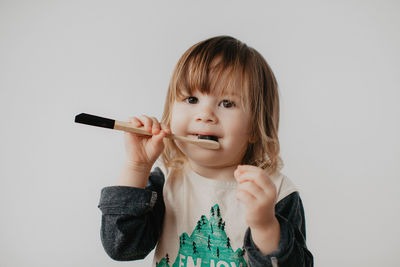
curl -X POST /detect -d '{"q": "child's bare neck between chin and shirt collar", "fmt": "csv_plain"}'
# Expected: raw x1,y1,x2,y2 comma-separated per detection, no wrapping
188,160,238,181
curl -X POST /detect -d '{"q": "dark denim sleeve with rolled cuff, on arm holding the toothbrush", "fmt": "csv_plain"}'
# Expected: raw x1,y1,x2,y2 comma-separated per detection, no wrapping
98,168,165,261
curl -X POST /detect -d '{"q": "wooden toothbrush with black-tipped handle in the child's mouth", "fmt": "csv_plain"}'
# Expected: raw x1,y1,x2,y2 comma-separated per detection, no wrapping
75,113,219,149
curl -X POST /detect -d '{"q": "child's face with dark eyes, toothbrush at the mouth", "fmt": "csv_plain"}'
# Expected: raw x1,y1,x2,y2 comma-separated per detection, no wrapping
170,87,250,171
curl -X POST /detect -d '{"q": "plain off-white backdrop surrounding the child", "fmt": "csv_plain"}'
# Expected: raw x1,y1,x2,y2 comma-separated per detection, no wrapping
0,0,400,267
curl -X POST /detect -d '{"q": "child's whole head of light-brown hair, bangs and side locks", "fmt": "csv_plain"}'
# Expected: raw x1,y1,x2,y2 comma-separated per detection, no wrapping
161,36,283,174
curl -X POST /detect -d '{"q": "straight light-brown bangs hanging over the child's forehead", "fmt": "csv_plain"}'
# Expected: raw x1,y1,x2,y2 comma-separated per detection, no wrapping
173,37,248,103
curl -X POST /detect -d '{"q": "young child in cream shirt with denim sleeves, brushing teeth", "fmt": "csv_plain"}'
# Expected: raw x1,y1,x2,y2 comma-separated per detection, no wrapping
99,36,313,267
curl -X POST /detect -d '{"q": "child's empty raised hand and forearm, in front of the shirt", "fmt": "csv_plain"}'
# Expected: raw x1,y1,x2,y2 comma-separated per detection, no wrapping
234,165,280,253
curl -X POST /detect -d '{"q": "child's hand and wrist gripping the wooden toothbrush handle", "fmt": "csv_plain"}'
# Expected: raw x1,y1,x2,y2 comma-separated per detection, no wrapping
125,115,171,170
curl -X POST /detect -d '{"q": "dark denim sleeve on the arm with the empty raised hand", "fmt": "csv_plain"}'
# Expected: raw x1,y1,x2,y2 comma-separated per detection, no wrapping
244,192,313,267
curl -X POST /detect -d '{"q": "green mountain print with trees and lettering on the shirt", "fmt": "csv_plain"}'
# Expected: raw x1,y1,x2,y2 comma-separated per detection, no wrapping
156,204,247,267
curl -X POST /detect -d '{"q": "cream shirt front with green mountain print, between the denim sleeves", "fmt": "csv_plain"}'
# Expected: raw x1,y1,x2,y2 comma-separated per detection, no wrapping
153,167,296,267
